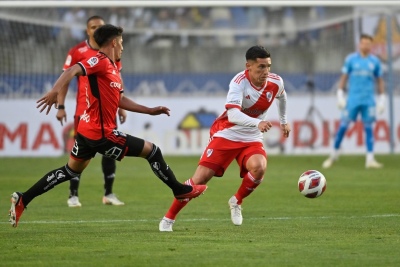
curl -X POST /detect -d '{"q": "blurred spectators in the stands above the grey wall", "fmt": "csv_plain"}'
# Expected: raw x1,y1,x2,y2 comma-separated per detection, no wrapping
0,6,351,47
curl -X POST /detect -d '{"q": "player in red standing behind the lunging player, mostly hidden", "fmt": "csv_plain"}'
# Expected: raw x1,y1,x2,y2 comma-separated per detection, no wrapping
56,16,126,207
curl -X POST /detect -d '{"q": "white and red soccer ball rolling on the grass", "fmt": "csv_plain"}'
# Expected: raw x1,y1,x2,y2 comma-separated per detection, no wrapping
297,170,326,198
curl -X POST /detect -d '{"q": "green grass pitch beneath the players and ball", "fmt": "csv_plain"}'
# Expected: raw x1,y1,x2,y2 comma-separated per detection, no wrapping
0,155,400,267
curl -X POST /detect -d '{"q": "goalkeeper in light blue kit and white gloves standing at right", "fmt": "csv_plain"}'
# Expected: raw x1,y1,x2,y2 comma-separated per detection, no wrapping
322,34,385,168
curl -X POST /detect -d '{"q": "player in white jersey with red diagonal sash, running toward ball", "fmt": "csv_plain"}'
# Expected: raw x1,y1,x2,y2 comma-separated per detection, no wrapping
159,46,290,232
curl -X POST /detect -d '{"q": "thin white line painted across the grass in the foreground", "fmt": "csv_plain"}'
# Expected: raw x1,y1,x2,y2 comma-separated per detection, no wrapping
0,214,400,224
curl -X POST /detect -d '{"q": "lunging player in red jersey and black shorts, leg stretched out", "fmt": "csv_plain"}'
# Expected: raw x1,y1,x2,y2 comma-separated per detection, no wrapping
9,24,207,227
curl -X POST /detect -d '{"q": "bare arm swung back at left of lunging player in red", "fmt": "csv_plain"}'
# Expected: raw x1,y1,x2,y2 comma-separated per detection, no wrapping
36,64,83,115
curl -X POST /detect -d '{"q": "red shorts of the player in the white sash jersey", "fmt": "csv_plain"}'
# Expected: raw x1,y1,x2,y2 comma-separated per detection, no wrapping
199,137,267,178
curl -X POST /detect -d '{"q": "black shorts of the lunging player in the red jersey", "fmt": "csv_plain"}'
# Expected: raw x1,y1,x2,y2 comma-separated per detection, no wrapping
71,130,145,161
